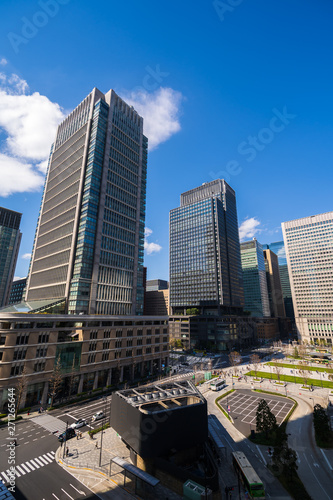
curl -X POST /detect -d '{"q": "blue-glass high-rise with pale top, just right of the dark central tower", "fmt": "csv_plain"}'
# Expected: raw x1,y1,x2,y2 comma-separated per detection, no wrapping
240,238,270,317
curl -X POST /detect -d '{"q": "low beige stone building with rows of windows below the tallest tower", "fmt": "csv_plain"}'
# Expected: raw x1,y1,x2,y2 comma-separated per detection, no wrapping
0,310,169,412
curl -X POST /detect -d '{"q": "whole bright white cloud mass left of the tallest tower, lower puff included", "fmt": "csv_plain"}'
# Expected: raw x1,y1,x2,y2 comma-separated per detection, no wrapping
0,70,64,196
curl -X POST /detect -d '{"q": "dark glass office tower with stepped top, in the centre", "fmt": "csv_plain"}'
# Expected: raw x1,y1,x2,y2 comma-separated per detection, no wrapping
170,179,244,314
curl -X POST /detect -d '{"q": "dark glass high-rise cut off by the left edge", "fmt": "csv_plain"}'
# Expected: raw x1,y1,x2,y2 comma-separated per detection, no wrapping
0,207,22,307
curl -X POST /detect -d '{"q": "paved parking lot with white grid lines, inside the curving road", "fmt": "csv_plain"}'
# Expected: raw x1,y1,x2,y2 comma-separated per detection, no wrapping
220,389,294,436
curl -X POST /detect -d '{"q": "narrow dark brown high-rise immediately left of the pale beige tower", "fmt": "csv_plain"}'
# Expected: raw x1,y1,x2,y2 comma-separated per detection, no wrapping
264,250,286,318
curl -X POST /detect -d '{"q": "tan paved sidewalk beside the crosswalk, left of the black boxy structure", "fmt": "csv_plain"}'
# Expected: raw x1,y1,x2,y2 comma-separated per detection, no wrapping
55,428,181,500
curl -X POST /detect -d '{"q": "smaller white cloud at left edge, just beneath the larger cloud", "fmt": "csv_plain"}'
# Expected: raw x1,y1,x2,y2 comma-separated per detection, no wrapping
0,153,44,197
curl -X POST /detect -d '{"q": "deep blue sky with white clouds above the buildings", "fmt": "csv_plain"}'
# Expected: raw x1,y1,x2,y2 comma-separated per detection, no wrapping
0,0,333,279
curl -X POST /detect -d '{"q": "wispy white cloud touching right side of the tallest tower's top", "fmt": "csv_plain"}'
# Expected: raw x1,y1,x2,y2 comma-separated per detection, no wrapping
124,87,183,151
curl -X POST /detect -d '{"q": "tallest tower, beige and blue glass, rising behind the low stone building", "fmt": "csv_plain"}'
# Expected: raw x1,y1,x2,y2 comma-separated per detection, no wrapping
25,88,147,315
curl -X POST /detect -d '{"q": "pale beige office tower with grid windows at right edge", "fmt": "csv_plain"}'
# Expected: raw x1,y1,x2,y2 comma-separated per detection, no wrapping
282,212,333,345
